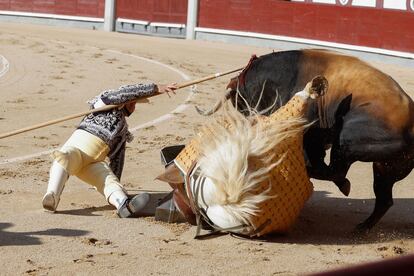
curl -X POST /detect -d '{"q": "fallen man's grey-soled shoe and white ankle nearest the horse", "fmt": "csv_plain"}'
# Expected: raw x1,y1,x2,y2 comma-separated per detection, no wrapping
108,191,150,218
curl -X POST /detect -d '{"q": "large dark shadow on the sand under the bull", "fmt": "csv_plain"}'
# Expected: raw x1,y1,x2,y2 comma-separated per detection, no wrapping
262,191,414,245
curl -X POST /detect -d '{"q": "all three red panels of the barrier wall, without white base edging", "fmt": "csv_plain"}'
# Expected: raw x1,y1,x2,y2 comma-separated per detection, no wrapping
0,0,414,53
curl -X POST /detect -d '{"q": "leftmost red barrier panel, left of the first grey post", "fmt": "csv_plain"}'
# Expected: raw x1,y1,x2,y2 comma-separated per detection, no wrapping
0,0,105,18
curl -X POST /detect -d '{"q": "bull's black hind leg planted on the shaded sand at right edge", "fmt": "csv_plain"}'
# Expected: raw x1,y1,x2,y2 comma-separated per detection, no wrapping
357,160,413,232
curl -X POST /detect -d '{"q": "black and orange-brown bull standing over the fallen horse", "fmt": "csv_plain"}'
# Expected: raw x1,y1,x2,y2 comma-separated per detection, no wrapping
197,50,414,230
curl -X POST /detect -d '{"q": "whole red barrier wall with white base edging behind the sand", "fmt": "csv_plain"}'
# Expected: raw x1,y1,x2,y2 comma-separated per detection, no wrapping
0,0,414,59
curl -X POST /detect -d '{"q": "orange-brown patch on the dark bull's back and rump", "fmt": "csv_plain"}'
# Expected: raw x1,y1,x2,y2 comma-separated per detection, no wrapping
298,50,413,134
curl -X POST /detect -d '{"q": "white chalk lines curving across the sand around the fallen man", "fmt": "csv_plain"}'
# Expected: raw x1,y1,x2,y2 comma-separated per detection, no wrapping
0,50,193,165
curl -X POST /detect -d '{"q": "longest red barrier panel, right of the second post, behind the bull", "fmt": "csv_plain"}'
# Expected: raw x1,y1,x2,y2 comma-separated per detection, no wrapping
198,0,414,52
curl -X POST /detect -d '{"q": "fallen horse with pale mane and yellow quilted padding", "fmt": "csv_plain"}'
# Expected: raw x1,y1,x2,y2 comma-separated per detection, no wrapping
158,76,327,237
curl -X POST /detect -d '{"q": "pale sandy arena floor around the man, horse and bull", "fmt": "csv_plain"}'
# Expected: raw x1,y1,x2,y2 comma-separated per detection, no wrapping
0,23,414,275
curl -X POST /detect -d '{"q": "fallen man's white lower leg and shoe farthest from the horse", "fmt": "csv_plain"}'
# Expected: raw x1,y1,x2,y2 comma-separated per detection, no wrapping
42,161,69,212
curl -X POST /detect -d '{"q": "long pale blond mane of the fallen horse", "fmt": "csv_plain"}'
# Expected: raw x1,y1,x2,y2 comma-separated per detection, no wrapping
195,100,305,223
